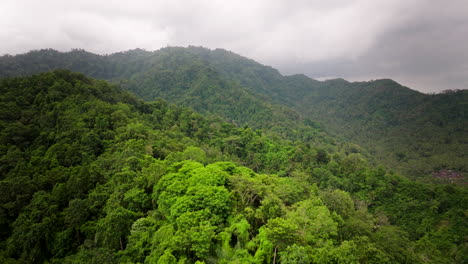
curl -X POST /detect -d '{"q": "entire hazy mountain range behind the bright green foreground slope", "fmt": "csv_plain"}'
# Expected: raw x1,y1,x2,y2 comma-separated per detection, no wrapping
0,47,468,179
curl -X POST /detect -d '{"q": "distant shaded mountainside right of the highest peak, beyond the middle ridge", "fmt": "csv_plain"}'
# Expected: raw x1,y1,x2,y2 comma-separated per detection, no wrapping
181,47,468,178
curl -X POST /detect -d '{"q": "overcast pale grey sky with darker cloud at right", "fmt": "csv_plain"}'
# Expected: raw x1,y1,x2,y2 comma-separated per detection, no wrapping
0,0,468,93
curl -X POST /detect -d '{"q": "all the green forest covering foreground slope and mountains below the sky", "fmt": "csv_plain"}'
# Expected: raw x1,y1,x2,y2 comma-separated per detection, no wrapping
0,47,468,264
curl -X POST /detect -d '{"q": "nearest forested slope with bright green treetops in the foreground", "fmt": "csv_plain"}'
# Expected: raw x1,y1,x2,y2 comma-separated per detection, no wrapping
0,70,468,263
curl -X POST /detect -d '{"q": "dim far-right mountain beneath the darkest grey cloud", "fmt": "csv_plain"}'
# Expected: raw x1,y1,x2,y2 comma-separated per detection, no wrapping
292,80,468,177
